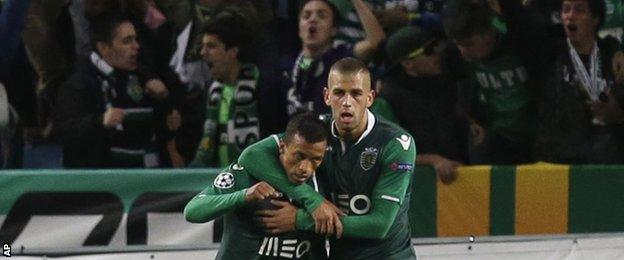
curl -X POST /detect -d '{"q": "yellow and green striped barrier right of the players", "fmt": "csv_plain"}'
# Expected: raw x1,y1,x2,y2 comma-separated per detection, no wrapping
410,163,624,237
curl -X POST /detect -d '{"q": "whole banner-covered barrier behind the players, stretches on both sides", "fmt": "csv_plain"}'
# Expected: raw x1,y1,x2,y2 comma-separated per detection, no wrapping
0,164,624,255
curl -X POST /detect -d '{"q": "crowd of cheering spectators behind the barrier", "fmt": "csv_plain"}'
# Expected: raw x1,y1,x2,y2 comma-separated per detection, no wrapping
0,0,624,182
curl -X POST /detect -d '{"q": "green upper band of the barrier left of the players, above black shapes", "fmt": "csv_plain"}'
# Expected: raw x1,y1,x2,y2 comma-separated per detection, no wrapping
0,169,219,215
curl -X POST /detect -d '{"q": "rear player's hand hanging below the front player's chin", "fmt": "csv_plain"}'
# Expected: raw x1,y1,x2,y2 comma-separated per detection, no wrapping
312,200,345,238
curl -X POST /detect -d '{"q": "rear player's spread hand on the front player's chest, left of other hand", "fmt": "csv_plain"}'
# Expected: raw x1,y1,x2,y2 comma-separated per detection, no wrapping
256,200,297,234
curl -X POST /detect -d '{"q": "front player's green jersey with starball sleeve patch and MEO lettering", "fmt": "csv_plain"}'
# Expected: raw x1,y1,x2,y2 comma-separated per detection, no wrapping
185,164,326,260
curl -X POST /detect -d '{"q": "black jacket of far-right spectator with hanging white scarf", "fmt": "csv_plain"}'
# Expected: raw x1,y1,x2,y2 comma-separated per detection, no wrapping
535,39,624,164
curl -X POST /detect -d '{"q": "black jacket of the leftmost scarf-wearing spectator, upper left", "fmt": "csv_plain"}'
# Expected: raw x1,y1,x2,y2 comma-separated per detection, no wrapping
54,55,166,168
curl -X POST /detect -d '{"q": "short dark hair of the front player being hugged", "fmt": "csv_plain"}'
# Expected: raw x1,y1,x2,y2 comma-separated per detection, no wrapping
284,112,328,143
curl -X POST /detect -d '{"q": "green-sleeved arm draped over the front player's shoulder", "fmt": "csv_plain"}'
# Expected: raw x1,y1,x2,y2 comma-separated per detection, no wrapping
238,136,325,212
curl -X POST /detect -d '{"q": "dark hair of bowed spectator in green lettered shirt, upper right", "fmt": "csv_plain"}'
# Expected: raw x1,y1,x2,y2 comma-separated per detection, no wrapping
443,0,495,41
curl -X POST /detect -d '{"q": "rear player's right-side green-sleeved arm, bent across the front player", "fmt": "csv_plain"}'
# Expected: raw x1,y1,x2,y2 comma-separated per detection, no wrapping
296,135,416,239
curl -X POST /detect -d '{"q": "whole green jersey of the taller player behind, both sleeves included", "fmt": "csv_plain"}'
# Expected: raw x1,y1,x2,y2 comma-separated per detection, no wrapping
238,115,416,259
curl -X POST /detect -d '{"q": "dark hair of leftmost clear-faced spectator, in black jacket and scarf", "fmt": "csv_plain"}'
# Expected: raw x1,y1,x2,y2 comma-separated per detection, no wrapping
89,10,132,50
